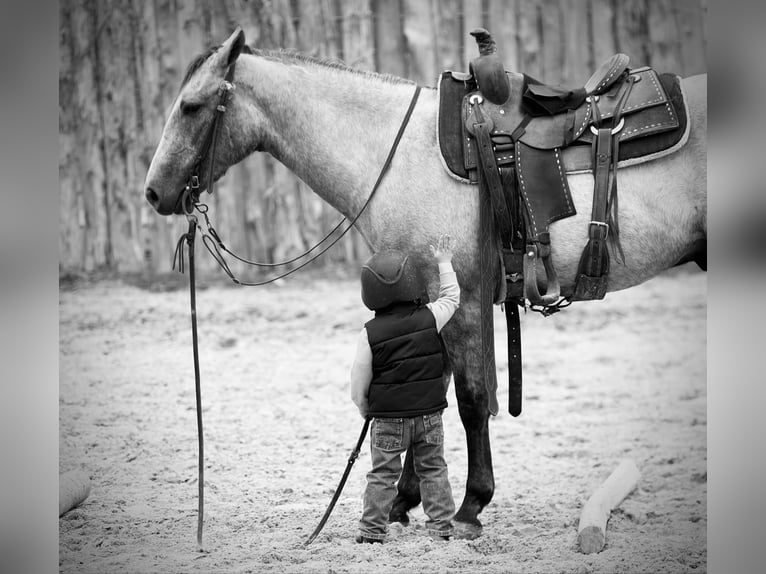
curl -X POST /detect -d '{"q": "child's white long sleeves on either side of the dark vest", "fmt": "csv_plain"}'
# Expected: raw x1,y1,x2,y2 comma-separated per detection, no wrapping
351,261,460,416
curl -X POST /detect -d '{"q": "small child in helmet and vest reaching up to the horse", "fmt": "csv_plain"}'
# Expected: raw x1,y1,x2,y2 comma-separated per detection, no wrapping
351,235,460,543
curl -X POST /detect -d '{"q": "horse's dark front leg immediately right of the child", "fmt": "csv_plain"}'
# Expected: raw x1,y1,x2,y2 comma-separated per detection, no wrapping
444,294,495,539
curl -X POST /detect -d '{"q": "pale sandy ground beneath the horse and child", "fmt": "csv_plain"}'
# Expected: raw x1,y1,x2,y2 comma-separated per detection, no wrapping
59,268,707,574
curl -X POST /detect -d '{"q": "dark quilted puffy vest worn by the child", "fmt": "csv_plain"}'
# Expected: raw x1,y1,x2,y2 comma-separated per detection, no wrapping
365,303,447,417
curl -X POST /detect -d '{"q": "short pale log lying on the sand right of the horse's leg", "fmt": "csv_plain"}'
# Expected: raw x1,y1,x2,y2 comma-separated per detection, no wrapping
577,459,641,554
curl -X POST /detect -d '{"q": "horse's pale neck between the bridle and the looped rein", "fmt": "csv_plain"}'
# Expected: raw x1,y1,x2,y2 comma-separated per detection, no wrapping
237,56,424,216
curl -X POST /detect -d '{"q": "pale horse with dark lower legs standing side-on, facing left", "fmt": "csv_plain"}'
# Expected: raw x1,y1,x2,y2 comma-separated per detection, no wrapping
145,29,707,539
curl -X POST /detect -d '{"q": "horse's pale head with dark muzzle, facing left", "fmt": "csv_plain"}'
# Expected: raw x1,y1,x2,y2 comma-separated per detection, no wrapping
144,28,252,215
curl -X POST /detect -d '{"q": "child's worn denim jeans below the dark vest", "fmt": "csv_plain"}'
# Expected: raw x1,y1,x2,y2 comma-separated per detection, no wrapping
359,411,455,540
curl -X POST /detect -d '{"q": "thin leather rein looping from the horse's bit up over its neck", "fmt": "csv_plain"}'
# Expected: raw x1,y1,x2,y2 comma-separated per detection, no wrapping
186,85,421,287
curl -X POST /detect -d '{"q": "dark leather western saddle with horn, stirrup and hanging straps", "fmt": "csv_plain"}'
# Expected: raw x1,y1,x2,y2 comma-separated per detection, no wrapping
438,28,688,416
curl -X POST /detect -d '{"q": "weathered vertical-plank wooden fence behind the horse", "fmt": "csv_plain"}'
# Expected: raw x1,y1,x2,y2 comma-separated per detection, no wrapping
59,0,707,280
